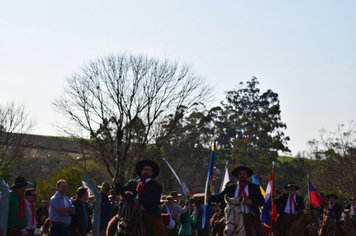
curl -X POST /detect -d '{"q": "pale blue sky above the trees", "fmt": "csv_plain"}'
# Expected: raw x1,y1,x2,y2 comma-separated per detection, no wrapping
0,0,356,155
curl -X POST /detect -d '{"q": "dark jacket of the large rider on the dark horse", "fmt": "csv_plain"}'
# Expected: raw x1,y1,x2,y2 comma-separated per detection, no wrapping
116,179,162,219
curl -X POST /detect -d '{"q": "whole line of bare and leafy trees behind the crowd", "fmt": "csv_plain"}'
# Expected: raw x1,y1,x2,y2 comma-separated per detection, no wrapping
0,53,356,206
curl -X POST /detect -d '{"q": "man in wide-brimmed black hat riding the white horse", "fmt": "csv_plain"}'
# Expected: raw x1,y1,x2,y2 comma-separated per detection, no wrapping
210,166,265,236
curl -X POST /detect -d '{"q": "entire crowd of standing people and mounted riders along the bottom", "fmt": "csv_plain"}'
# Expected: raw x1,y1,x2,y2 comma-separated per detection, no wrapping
0,160,356,236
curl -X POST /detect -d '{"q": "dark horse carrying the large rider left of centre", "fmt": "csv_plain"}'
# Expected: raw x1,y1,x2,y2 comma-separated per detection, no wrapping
106,192,168,236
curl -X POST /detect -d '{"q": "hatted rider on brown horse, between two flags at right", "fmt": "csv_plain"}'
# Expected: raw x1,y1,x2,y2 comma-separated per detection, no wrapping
273,182,305,234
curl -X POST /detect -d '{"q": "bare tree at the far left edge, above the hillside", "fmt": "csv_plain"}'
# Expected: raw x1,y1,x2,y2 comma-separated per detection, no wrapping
0,101,36,179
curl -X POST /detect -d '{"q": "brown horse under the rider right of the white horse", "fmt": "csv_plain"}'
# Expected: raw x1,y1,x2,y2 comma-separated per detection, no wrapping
273,209,313,236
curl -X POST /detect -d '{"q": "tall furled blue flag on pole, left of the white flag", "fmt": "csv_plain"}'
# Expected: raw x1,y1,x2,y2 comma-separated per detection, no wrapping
202,142,215,233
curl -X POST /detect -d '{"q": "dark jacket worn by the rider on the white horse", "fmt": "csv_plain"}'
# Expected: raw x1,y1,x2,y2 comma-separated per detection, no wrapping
210,182,265,219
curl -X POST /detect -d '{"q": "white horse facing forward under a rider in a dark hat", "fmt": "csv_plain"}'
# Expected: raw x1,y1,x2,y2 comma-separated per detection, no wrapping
224,194,247,236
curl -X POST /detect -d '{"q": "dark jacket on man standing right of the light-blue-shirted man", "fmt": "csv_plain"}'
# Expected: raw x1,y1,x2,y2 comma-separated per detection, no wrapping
70,199,92,235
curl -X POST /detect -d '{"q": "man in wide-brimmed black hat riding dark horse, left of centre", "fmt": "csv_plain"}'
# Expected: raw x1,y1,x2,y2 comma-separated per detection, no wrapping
114,160,164,235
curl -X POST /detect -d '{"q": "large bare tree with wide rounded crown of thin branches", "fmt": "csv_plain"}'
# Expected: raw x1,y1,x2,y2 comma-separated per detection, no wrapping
53,54,211,181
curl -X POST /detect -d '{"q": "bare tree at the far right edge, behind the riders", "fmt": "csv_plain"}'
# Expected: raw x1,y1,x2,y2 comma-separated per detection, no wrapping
309,121,356,200
